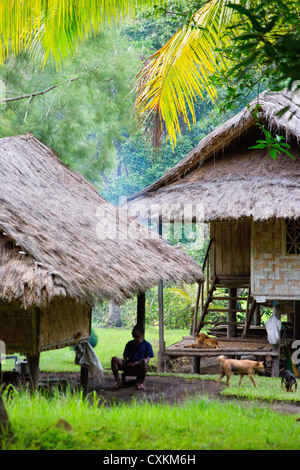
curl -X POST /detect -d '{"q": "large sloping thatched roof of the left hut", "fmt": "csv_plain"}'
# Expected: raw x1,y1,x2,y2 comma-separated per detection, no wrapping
0,135,203,306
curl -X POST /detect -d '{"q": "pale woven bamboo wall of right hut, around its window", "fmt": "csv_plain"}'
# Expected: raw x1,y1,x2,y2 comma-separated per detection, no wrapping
251,219,300,300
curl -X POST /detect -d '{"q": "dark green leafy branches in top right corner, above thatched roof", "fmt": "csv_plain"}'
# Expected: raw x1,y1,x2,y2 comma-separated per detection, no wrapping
213,0,300,109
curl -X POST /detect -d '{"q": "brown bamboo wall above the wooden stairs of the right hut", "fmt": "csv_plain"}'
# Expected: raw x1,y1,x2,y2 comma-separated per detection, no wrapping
210,220,251,282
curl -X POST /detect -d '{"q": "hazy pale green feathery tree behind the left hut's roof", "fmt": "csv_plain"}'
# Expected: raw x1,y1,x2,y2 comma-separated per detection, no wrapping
0,30,140,187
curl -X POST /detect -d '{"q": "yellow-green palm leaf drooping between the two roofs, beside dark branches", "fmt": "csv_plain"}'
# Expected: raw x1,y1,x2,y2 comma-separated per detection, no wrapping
134,0,242,145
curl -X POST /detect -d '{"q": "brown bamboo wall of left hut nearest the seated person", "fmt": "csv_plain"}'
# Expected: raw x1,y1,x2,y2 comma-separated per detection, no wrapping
39,297,91,351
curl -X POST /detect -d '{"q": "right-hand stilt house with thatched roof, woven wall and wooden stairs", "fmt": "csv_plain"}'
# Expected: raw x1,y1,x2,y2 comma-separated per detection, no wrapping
130,92,300,375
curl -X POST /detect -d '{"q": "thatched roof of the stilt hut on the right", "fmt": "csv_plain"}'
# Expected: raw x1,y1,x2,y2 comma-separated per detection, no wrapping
130,92,300,221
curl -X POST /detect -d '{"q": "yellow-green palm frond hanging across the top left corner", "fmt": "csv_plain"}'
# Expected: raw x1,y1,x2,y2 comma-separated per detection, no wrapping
0,0,159,64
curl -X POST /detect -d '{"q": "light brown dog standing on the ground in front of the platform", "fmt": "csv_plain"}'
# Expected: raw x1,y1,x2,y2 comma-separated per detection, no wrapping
217,356,265,387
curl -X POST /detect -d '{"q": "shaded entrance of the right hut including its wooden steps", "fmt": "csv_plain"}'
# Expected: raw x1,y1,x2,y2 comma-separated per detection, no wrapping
194,220,251,338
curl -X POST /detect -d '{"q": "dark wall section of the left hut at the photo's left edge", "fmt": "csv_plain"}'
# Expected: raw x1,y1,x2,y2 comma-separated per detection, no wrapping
0,301,37,354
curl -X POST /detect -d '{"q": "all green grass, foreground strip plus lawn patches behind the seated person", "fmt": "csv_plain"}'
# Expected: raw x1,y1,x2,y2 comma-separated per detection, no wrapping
1,327,300,451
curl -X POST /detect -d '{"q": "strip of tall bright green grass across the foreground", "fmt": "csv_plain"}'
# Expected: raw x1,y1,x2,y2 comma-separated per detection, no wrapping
2,392,300,451
